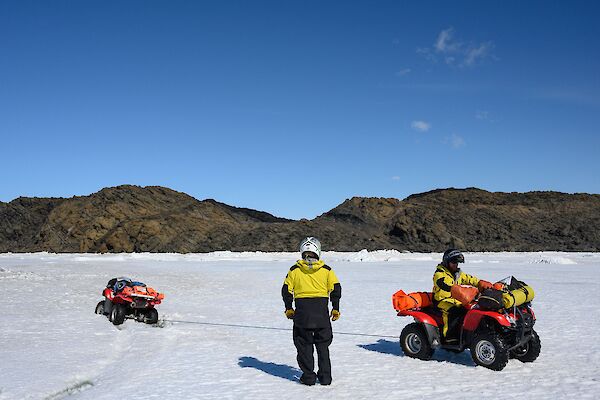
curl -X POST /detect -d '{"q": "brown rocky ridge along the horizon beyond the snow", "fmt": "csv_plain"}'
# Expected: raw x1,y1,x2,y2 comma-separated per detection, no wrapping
0,185,600,253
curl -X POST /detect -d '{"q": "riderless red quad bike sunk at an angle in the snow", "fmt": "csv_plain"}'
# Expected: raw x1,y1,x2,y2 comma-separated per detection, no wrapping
96,277,165,325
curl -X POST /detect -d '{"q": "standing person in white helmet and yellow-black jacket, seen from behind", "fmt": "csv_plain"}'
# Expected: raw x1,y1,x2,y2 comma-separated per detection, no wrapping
281,237,342,385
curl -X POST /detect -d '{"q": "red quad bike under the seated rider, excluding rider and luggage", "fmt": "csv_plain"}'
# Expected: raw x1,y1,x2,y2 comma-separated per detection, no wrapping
398,294,541,371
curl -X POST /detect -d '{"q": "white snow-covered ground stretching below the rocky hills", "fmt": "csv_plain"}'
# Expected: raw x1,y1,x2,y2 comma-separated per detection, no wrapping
0,251,600,400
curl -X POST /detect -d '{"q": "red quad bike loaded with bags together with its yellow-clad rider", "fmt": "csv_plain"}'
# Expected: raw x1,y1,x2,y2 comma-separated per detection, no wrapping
392,249,541,371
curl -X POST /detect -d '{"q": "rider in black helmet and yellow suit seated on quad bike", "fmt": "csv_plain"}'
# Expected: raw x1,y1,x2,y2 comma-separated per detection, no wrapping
433,249,491,343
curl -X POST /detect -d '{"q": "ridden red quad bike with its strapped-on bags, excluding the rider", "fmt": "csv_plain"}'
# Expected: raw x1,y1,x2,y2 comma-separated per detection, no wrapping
393,277,541,371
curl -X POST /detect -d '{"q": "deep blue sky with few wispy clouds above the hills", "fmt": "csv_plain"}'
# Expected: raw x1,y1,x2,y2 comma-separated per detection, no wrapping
0,0,600,219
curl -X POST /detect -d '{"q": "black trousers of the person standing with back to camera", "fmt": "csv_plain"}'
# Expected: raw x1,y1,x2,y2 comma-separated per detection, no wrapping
294,325,333,385
